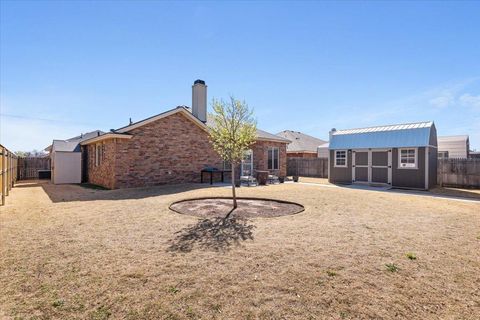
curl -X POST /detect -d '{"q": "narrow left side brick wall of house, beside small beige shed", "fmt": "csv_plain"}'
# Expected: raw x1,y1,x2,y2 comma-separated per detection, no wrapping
86,139,116,189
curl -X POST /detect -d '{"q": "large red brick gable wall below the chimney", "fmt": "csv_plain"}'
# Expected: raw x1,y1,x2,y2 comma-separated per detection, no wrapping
114,113,222,188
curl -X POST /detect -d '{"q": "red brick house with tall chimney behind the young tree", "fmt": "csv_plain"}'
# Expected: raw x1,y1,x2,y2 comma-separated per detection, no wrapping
81,80,290,189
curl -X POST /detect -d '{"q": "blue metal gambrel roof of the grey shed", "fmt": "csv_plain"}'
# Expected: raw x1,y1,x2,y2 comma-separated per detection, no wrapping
329,121,435,149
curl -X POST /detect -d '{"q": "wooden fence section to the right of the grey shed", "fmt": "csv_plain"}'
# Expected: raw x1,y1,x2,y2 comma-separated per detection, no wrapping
437,159,480,188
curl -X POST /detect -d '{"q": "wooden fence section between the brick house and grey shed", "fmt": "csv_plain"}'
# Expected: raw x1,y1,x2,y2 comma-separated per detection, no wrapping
287,158,328,178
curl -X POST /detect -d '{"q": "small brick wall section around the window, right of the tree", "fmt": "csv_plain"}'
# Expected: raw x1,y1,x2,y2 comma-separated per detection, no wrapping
252,141,287,177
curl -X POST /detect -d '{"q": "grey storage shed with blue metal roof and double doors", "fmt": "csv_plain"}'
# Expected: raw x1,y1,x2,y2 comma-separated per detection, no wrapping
328,122,437,190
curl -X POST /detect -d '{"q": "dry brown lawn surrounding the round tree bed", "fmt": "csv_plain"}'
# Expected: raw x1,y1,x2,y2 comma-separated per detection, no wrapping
0,182,480,319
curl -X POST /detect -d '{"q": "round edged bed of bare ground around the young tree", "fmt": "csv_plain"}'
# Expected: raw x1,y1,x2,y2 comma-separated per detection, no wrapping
170,197,304,218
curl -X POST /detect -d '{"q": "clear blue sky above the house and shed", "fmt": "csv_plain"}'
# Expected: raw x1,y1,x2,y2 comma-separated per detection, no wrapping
0,1,480,150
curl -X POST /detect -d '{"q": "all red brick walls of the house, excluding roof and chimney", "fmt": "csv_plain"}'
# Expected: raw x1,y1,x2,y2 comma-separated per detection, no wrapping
87,113,287,189
